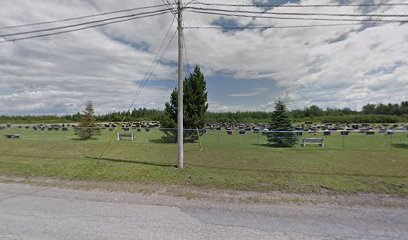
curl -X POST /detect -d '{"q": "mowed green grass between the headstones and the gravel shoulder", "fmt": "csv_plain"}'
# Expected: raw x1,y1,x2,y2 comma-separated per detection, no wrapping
0,129,408,195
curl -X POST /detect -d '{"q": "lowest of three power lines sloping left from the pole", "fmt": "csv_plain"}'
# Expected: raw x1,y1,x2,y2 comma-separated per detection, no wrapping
0,12,171,44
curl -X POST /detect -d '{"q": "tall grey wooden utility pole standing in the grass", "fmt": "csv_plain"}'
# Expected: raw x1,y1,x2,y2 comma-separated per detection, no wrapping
177,0,184,169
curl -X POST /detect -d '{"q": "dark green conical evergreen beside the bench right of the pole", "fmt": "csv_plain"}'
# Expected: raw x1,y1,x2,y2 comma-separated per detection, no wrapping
268,99,297,147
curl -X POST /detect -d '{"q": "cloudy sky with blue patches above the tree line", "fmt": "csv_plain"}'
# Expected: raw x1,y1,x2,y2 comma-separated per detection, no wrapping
0,0,408,115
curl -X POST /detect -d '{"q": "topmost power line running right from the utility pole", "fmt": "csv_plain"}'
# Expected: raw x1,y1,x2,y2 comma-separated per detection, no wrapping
192,1,408,8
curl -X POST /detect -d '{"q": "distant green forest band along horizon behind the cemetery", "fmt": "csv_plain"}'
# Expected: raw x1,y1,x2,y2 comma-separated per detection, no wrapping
0,101,408,124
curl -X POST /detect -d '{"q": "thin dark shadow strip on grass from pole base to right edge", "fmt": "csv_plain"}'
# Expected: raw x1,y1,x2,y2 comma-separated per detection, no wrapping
186,163,407,178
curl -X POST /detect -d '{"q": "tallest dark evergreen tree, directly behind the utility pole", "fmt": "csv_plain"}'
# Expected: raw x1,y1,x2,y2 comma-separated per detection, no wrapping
161,66,208,142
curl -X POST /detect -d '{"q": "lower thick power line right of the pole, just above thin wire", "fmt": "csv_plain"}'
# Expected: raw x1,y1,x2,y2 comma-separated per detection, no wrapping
186,10,408,23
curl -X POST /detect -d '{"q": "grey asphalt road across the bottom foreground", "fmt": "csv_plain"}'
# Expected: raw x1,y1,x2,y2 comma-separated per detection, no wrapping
0,184,408,240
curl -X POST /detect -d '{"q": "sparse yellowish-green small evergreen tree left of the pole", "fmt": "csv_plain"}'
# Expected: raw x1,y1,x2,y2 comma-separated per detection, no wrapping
77,101,101,140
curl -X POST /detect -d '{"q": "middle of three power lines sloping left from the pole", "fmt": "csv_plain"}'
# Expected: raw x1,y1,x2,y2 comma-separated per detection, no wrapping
0,9,169,38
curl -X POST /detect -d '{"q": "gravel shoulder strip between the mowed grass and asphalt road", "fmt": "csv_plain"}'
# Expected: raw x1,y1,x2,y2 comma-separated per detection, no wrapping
0,176,408,209
